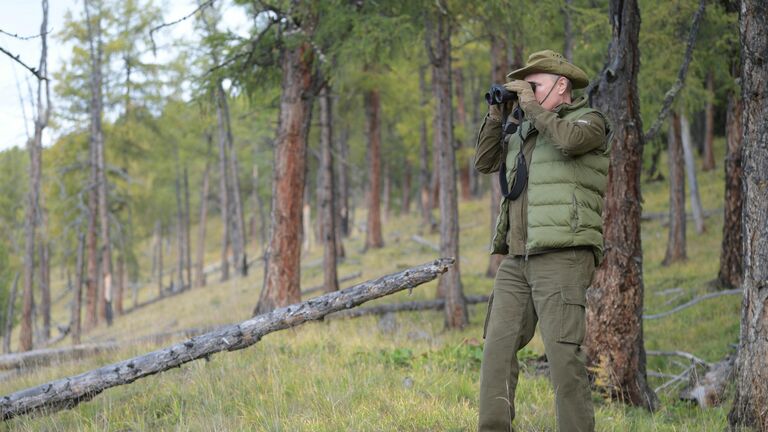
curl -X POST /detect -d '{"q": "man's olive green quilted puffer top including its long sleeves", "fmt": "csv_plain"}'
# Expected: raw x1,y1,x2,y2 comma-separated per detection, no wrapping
475,98,611,263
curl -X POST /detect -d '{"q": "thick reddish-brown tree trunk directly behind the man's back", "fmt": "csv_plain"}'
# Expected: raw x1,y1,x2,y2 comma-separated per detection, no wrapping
584,0,658,410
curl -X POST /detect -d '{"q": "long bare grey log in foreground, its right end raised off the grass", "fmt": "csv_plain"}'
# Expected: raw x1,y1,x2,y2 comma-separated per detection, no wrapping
0,258,454,420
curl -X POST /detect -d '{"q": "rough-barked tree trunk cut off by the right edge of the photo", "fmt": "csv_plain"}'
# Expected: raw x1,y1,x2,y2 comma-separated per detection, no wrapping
728,0,768,431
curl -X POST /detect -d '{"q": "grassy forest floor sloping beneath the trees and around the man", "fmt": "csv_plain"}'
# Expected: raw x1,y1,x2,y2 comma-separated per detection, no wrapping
0,140,740,431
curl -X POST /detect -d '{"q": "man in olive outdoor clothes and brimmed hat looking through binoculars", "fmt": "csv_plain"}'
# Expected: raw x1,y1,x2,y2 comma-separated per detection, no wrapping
475,50,610,431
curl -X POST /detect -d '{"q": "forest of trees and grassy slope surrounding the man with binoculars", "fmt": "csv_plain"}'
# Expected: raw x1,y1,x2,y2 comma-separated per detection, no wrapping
0,0,768,431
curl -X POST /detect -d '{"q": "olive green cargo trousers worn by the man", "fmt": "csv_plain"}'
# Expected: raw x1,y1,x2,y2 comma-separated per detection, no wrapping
479,248,595,432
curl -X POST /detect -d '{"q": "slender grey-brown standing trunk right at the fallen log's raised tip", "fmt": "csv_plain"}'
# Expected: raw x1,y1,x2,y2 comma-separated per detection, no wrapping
425,5,469,329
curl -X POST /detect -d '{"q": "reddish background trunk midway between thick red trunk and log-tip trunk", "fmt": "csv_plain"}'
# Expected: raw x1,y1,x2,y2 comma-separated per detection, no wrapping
363,89,384,250
